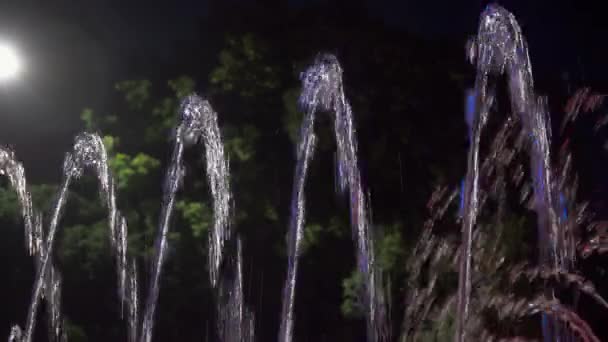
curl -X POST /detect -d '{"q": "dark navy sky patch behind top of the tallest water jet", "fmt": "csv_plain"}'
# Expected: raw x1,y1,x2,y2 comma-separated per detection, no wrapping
373,0,608,82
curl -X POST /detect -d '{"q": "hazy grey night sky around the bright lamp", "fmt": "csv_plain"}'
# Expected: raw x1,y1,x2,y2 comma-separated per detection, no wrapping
0,0,206,182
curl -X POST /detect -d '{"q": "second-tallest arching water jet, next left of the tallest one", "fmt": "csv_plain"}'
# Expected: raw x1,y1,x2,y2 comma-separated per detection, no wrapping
279,54,389,342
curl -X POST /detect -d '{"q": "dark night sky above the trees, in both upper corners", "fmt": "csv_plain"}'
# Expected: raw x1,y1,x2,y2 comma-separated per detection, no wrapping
0,0,608,180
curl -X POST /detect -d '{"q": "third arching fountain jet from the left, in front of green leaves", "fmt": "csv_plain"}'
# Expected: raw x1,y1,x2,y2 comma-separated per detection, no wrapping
140,95,253,342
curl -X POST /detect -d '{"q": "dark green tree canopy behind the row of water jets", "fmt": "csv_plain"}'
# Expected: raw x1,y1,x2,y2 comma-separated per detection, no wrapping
0,3,604,341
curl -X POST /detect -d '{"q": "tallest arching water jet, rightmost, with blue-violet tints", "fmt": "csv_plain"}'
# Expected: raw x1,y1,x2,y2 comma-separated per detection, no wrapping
455,5,563,342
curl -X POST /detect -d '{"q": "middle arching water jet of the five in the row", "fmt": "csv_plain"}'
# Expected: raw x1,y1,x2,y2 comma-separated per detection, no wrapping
140,95,244,342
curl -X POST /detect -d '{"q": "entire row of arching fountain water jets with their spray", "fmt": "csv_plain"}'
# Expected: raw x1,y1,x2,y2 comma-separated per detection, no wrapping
0,5,608,342
